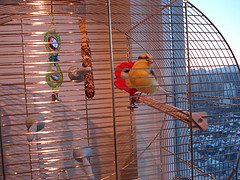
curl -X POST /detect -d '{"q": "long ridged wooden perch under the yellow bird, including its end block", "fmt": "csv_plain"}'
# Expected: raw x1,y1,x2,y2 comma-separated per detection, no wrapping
137,96,208,130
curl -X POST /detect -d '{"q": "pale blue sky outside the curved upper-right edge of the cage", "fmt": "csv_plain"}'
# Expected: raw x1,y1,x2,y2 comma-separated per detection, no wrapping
188,0,240,64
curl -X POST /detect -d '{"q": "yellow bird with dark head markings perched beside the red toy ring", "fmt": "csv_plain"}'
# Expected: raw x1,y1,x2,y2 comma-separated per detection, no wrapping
126,54,159,94
